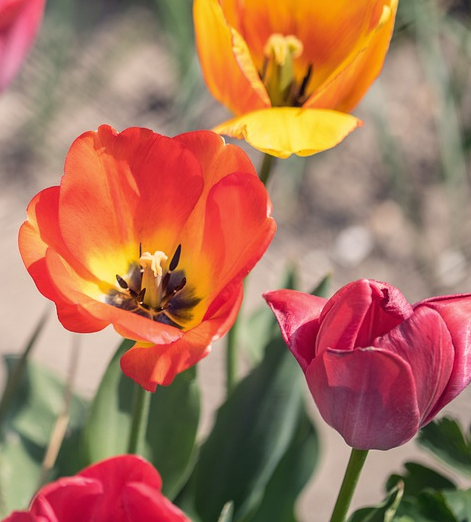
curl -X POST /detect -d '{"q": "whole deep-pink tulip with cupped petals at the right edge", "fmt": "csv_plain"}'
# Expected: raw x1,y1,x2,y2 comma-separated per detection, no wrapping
264,279,471,450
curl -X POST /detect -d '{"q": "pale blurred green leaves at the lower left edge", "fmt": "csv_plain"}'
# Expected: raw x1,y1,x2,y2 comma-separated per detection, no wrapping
0,356,86,516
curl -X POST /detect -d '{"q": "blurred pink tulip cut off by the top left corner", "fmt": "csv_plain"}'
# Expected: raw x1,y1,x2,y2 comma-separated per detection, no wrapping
0,0,46,91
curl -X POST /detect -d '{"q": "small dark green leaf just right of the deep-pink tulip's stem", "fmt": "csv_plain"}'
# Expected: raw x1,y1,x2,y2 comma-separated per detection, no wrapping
386,462,456,497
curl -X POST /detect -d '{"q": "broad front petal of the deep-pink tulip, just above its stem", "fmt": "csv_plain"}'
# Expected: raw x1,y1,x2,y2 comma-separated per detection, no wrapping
306,347,420,450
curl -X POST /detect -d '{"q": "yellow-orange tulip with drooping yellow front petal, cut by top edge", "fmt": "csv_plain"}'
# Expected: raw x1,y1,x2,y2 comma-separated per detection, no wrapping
194,0,397,158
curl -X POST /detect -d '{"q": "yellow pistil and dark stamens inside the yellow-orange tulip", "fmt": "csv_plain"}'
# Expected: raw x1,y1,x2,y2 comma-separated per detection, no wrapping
260,33,312,107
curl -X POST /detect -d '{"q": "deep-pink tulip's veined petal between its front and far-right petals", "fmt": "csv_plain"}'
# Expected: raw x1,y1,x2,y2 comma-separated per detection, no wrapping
373,307,455,425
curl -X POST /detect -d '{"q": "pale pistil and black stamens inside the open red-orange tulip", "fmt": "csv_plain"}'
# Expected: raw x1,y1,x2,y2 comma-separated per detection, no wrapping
106,245,200,328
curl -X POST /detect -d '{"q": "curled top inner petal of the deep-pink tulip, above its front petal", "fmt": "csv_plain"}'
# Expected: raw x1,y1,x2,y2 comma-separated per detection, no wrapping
316,279,412,354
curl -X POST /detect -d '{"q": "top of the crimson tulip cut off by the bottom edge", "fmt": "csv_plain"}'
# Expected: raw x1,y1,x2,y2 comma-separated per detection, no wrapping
3,455,189,522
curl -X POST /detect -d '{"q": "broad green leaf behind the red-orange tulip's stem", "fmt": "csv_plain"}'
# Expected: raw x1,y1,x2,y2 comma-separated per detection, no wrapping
84,340,200,498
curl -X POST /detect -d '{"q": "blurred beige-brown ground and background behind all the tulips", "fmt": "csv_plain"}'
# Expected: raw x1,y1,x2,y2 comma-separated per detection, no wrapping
0,0,471,521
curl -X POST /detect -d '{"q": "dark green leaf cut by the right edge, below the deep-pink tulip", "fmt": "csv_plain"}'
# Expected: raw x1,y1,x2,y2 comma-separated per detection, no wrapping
417,417,471,476
